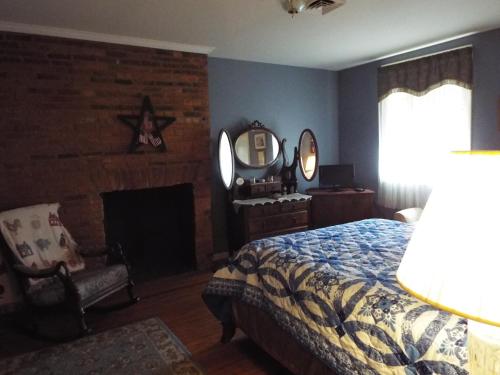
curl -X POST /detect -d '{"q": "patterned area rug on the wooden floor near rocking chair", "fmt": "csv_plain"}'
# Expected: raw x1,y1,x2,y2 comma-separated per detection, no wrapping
0,318,204,375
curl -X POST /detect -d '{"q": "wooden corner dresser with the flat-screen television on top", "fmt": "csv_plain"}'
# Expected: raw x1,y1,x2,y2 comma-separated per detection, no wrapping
307,188,375,228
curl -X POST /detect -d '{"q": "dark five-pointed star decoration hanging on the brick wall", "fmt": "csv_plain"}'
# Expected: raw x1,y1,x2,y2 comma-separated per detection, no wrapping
118,96,175,153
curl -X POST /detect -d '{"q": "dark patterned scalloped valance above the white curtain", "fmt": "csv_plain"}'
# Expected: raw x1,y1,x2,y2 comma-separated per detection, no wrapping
378,47,472,101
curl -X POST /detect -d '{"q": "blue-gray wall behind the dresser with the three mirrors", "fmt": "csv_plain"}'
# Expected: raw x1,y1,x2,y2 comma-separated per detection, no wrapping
208,58,339,252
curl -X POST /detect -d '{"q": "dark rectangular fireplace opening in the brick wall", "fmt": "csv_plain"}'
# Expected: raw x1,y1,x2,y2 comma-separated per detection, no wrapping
101,184,196,280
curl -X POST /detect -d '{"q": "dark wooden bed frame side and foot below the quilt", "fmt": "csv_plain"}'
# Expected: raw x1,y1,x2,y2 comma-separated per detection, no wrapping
221,301,337,375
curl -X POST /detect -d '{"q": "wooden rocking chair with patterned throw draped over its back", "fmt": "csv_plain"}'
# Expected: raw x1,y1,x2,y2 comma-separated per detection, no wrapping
0,203,138,334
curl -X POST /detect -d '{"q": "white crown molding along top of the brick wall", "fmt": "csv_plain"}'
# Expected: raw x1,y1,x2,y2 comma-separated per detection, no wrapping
0,21,215,55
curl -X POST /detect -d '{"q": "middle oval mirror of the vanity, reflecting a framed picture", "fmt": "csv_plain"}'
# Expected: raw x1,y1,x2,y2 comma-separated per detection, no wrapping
234,128,280,168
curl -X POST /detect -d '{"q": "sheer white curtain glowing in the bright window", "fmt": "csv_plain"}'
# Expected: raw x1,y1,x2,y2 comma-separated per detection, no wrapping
378,84,471,209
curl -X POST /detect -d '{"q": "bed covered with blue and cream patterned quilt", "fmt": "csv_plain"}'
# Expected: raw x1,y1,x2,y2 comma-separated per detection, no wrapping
203,219,468,375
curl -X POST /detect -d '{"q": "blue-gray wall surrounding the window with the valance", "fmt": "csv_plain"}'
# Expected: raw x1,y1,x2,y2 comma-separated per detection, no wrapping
339,29,500,189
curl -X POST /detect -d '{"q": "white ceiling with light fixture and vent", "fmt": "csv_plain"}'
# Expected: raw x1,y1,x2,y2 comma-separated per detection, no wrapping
0,0,500,70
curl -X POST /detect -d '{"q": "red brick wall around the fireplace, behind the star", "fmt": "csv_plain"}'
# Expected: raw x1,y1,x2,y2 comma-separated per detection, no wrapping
0,33,212,269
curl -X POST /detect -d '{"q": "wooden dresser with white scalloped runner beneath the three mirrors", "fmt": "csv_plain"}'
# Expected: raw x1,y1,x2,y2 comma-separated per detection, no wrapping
230,194,311,251
